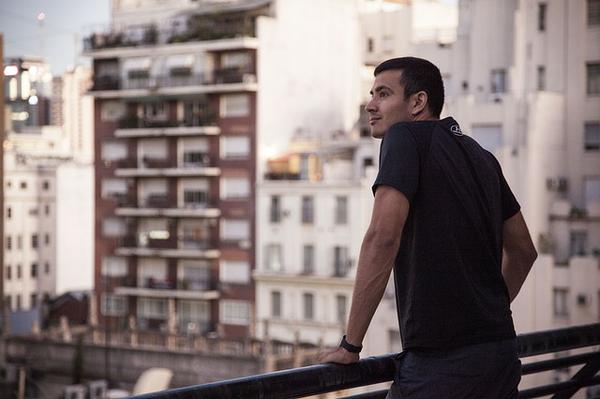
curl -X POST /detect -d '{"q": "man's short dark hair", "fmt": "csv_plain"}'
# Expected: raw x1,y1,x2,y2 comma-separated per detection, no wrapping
375,57,444,118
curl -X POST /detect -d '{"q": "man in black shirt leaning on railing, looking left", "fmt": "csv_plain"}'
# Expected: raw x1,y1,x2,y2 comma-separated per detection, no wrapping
321,57,537,399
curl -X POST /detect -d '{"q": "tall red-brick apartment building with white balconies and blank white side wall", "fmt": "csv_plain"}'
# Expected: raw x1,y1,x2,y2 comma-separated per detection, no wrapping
85,0,358,337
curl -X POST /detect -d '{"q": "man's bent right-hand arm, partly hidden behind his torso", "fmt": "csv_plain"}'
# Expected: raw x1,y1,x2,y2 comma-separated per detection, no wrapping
502,212,537,302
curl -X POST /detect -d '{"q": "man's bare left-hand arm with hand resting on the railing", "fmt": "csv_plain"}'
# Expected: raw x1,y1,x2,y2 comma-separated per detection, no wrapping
321,186,409,363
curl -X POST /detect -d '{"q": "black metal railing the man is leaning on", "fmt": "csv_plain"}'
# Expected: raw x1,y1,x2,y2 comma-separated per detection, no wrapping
134,323,600,399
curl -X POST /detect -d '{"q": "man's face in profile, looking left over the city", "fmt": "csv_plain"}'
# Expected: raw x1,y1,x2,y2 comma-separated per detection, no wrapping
365,69,413,138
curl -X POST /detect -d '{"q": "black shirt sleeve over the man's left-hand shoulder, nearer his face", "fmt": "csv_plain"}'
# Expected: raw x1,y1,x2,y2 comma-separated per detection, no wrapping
372,125,419,202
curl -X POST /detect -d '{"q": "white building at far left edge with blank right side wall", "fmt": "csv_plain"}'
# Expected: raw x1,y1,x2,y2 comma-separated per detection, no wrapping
4,126,93,318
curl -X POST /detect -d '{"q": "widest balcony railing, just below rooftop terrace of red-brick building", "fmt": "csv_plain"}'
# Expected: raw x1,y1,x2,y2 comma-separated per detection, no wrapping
92,68,256,90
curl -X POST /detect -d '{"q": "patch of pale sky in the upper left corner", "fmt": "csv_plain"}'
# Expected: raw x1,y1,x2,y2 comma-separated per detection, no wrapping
0,0,110,76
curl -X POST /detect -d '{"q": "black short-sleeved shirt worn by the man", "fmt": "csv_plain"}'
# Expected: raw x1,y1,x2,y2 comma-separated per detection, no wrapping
373,118,520,349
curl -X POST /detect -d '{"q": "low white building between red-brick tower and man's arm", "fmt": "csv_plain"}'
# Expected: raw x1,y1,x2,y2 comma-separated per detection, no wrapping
254,134,399,355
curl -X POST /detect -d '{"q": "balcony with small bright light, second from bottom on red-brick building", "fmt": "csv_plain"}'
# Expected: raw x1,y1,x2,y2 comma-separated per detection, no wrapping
115,235,221,259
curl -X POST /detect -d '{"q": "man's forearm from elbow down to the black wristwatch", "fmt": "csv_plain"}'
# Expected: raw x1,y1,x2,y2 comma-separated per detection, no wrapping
346,233,400,345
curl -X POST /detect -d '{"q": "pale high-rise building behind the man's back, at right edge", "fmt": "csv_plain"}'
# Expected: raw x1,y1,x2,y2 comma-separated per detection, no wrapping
447,0,600,392
